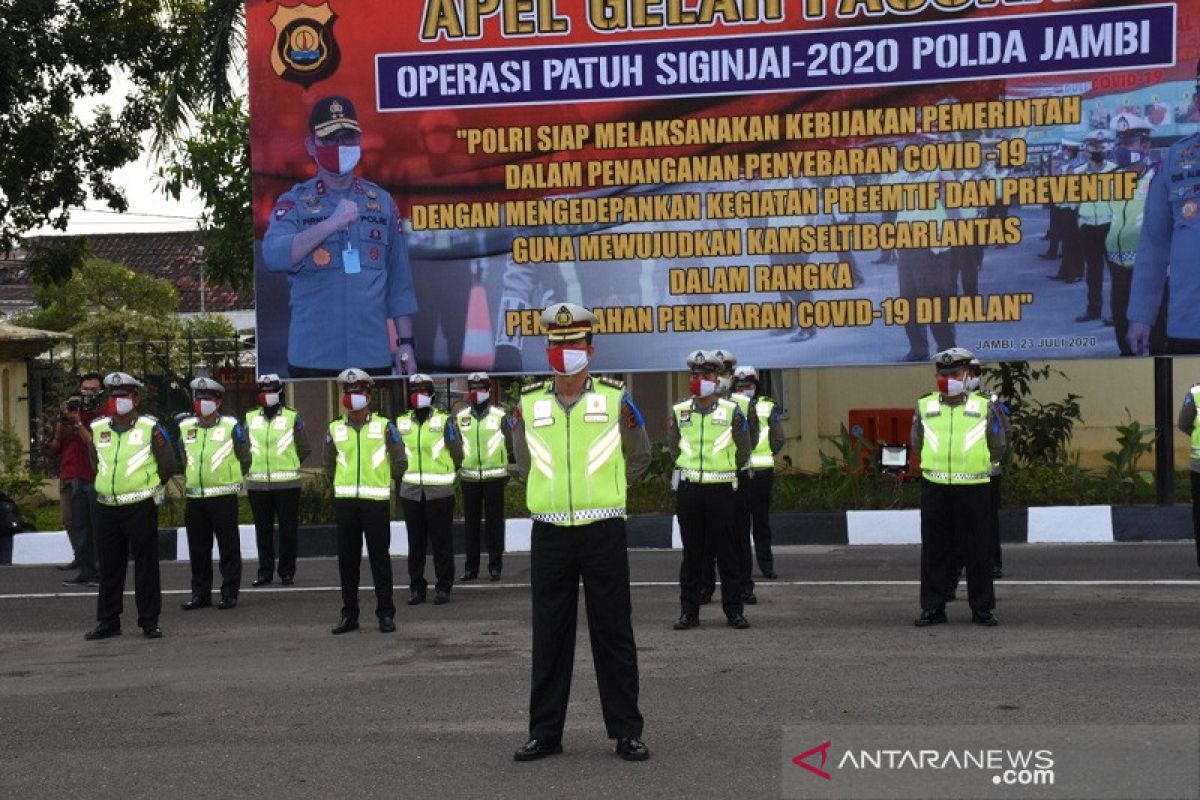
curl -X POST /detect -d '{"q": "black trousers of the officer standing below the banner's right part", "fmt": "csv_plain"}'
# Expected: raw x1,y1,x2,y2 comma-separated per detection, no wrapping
920,479,996,612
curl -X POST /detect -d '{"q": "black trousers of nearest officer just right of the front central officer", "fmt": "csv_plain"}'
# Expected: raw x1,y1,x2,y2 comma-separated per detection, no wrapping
676,481,746,616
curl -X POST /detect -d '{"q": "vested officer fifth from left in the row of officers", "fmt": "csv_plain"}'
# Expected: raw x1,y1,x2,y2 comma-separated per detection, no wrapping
396,374,462,606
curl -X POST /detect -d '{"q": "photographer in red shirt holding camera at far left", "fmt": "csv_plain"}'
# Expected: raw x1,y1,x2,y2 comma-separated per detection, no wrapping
50,372,103,587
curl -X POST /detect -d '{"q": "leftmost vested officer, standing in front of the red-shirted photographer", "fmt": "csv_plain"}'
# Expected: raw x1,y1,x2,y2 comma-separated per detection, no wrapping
79,372,175,640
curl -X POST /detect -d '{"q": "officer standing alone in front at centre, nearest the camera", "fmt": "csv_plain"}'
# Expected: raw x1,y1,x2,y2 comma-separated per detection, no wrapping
512,302,650,762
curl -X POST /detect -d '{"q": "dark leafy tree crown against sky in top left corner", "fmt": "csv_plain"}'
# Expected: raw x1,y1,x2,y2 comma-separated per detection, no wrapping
0,0,202,256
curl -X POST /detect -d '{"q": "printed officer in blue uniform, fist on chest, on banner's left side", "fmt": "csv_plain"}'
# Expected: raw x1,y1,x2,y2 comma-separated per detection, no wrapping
263,97,416,378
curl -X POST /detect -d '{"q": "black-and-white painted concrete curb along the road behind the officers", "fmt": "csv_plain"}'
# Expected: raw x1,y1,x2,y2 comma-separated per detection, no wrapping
0,505,1193,564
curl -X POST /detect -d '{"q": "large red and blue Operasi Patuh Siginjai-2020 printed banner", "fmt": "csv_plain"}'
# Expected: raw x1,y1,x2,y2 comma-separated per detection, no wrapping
247,0,1200,377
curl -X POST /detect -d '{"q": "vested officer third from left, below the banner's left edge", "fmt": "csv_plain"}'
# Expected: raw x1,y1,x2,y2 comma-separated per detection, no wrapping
246,374,312,587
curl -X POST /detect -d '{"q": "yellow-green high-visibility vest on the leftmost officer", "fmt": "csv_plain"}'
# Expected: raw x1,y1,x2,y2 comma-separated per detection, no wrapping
91,414,162,506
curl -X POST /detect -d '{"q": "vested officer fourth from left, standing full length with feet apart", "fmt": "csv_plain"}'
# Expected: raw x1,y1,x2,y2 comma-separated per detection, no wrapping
322,367,403,636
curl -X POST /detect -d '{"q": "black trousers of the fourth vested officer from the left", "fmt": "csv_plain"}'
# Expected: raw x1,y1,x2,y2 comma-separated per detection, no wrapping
334,498,396,621
